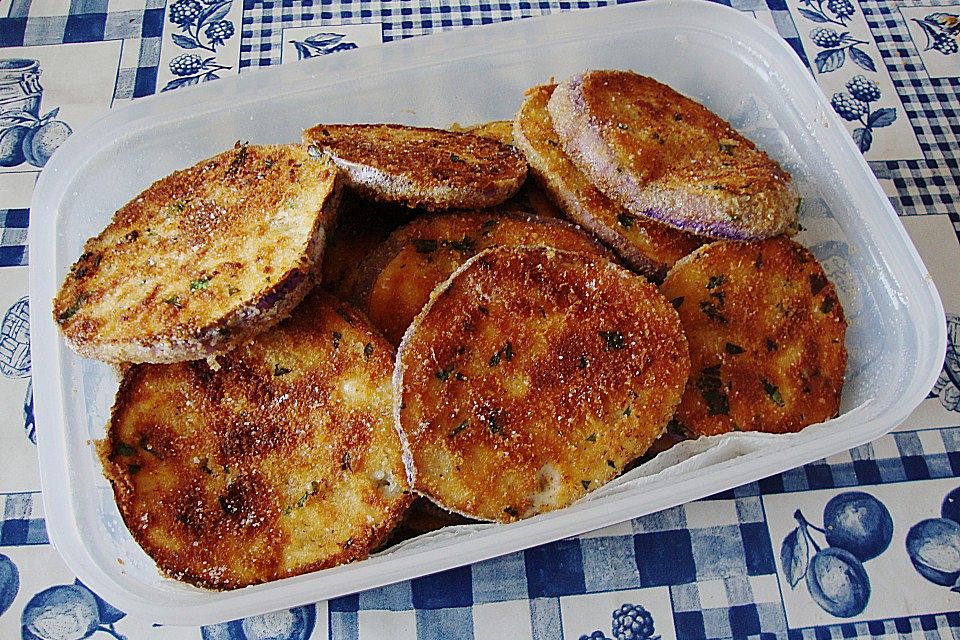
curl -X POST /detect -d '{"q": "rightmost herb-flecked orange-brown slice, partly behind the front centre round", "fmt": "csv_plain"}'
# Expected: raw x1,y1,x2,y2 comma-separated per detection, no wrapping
661,237,847,436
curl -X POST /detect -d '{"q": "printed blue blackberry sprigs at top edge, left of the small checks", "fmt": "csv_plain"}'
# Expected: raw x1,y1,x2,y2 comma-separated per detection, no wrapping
161,0,236,91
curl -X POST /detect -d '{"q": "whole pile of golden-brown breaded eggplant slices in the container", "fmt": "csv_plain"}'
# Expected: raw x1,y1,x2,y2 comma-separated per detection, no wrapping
54,71,846,589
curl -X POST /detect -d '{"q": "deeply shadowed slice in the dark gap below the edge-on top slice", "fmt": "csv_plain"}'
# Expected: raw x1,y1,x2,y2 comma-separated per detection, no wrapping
320,190,414,300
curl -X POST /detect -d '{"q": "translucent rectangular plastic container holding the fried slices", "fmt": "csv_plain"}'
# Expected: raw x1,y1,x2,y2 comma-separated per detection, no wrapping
30,1,945,625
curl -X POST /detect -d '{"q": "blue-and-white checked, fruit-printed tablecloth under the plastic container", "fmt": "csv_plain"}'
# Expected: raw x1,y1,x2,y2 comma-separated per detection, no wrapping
0,0,960,640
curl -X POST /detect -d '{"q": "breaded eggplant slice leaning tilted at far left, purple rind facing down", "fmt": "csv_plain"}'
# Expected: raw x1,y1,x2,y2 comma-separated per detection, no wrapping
53,145,339,363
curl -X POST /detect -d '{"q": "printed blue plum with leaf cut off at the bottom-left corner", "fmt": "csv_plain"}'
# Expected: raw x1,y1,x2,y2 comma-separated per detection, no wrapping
20,580,127,640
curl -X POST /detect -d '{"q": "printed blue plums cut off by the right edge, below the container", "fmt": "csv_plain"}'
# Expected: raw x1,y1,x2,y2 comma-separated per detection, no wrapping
906,487,960,593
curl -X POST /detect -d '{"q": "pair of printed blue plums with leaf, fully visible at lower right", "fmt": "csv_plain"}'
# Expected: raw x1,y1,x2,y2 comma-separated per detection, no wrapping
780,491,893,618
